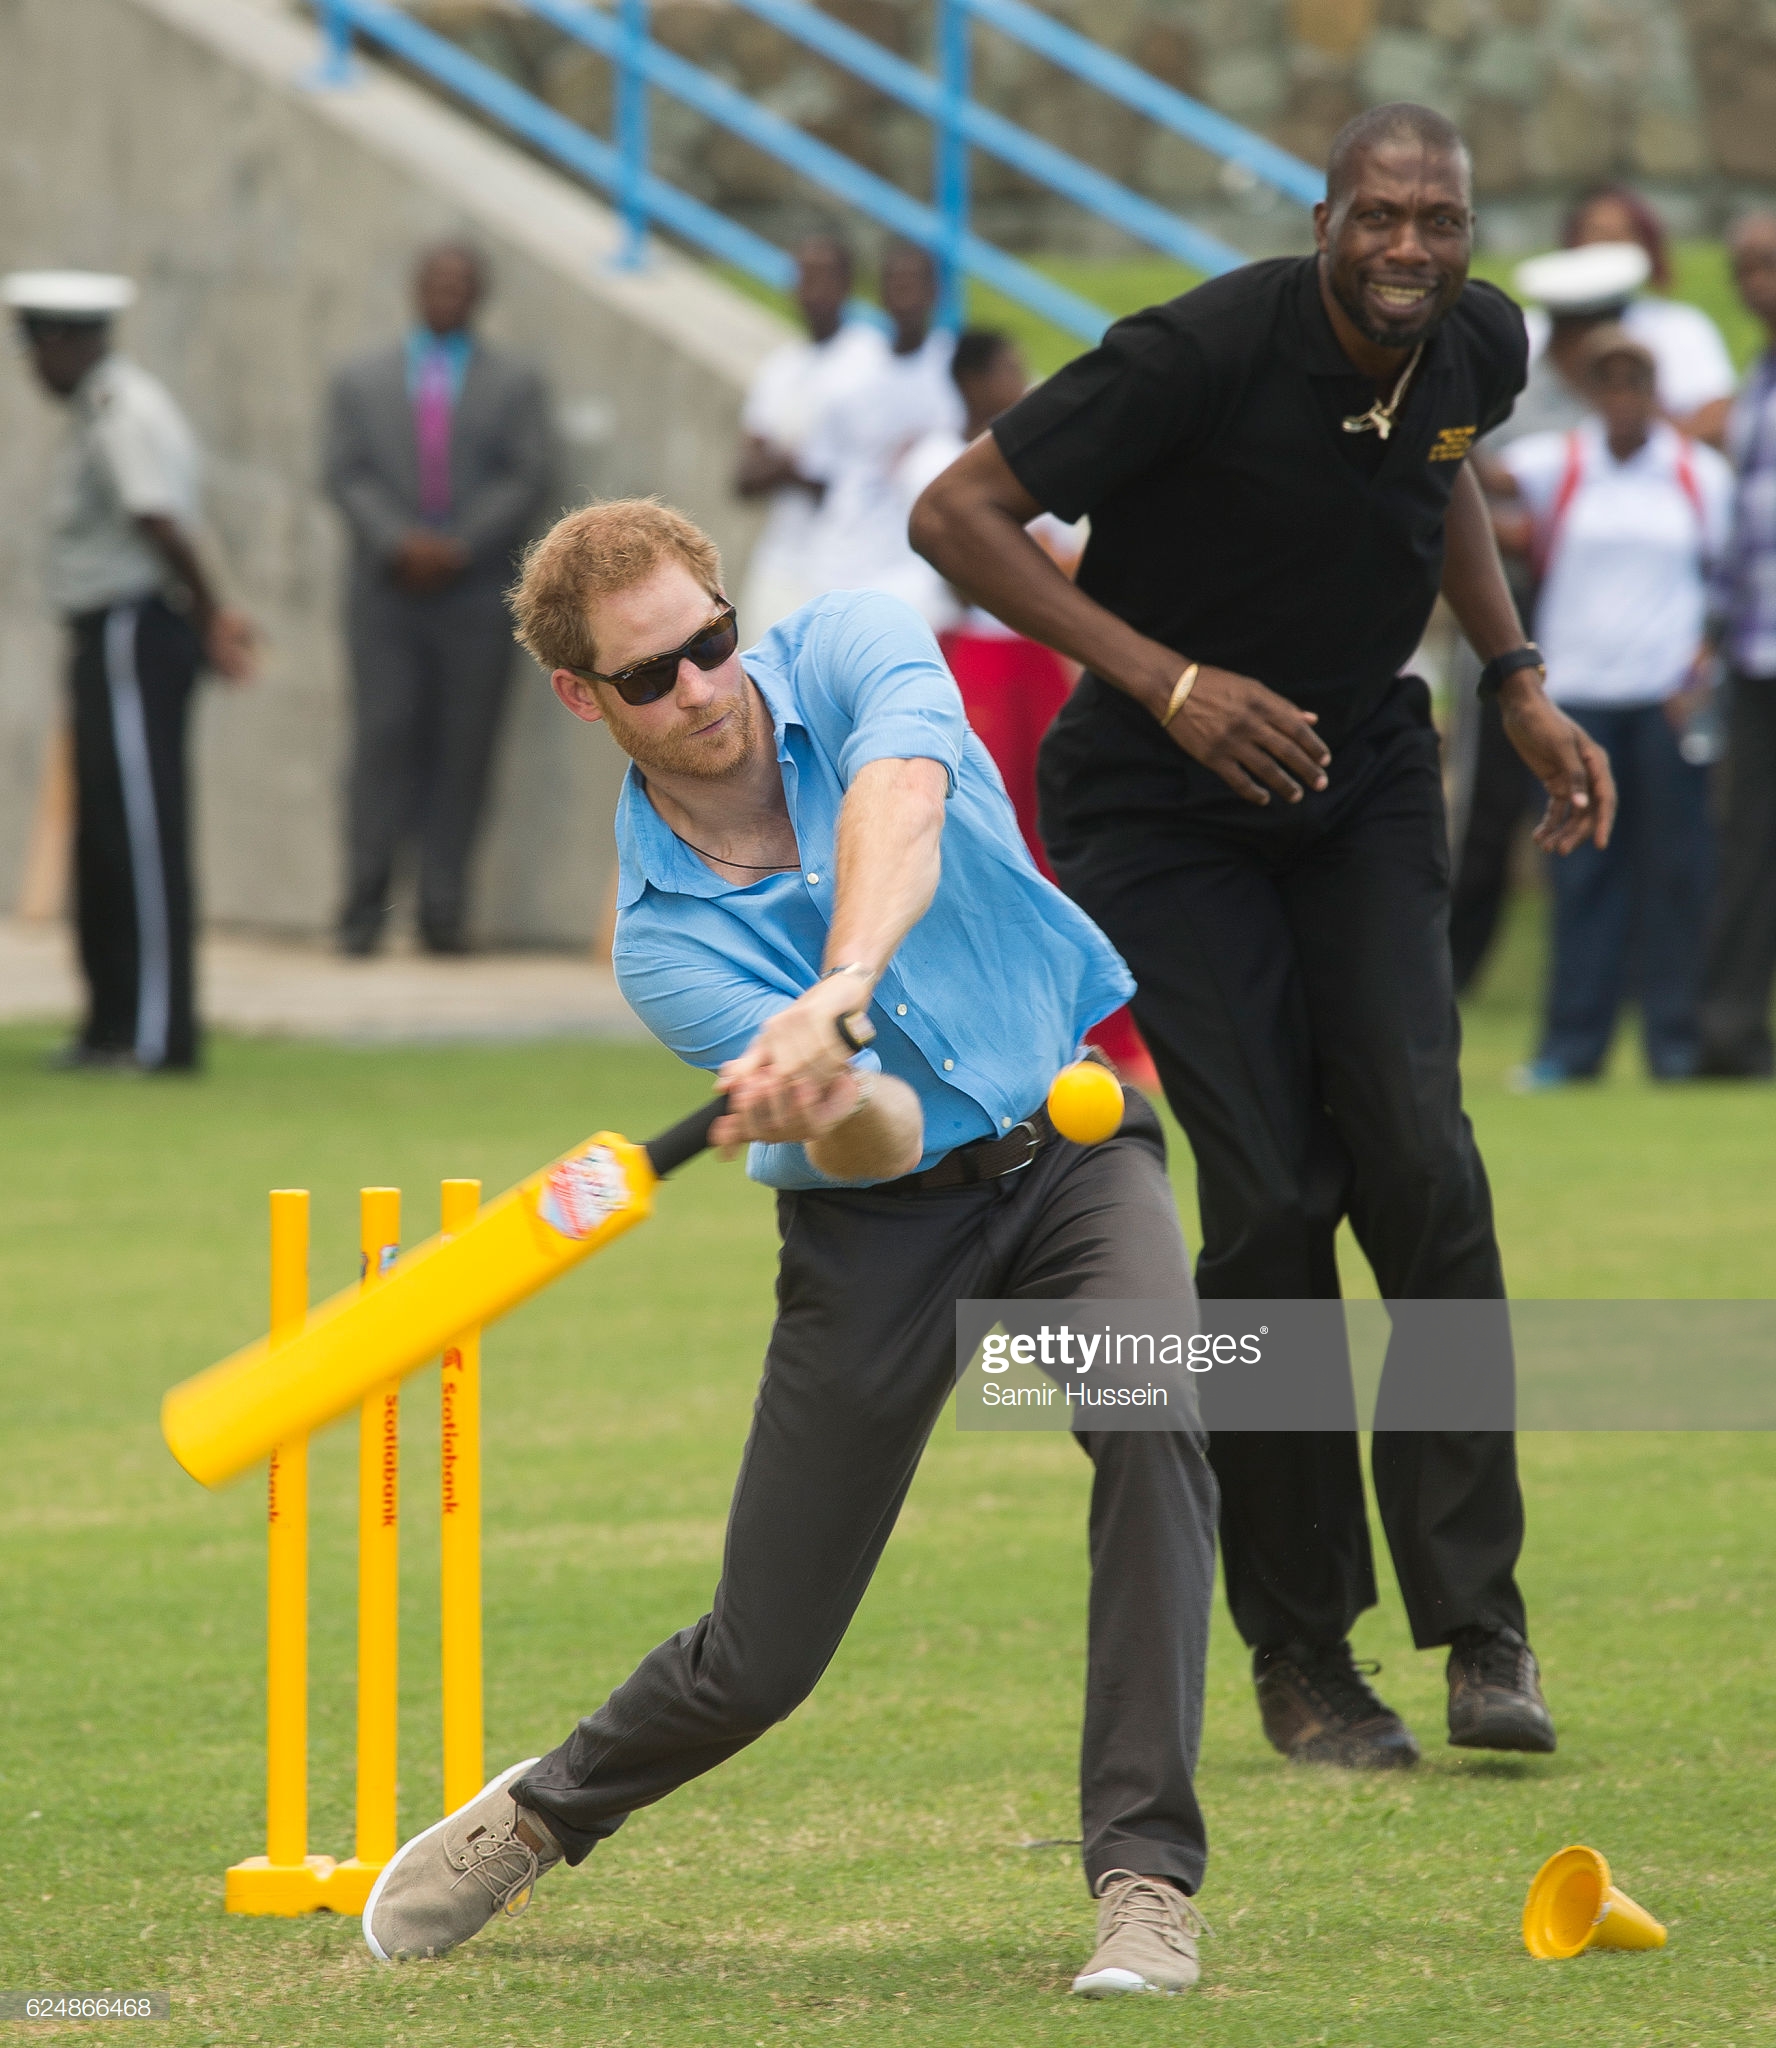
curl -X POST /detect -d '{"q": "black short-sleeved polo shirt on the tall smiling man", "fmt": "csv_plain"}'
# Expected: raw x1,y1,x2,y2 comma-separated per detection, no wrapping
993,256,1528,764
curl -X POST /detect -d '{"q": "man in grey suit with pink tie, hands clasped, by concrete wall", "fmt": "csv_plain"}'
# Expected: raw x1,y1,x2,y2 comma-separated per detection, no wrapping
326,244,555,954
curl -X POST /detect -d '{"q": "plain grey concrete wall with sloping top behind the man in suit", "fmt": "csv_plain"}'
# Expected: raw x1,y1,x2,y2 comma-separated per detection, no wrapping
0,0,783,944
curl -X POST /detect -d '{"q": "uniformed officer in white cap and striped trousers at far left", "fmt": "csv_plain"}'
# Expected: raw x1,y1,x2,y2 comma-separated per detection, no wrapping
0,270,254,1071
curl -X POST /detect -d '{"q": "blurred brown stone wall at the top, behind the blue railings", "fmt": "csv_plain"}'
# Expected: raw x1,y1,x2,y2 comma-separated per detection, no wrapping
428,0,1776,252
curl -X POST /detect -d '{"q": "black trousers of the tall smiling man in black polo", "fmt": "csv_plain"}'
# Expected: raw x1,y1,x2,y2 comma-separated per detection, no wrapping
1041,678,1524,1649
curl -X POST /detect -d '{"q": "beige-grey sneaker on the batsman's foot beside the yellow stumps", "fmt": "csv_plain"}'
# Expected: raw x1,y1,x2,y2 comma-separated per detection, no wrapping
365,1757,561,1962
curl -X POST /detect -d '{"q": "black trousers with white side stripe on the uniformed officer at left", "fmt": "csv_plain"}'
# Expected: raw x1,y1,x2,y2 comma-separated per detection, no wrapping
70,598,203,1067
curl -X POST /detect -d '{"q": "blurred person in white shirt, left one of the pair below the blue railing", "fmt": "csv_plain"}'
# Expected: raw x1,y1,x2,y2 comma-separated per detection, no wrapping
733,233,887,641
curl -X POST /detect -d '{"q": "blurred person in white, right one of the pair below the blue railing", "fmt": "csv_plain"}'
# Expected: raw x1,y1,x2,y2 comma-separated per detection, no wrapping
801,242,963,598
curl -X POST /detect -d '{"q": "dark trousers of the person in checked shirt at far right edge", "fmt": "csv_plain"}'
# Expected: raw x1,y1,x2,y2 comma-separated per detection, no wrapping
1698,676,1776,1073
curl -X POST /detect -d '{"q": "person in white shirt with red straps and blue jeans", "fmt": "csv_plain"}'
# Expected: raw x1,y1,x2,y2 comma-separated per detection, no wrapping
1499,328,1733,1090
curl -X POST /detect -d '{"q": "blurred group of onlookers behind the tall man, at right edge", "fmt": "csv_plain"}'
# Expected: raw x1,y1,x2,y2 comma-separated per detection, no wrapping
1450,186,1776,1092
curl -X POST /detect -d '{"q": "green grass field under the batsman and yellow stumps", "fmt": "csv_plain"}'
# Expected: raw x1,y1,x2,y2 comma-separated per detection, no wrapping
0,905,1776,2048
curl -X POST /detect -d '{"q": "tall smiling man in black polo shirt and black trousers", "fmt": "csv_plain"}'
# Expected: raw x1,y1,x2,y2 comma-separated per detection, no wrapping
912,104,1614,1765
